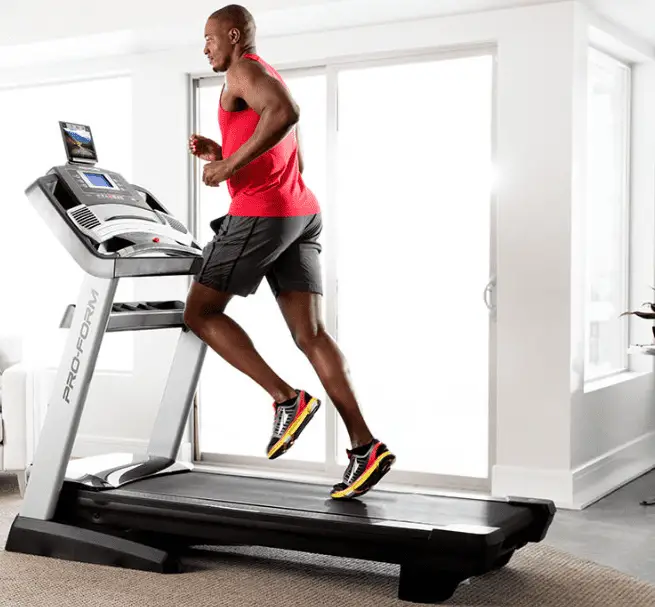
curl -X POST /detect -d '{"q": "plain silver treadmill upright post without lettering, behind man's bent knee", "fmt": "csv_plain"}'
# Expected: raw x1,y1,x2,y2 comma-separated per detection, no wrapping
148,327,207,460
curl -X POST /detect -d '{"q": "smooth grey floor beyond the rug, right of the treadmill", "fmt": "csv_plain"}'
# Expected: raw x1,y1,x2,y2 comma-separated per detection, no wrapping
545,472,655,584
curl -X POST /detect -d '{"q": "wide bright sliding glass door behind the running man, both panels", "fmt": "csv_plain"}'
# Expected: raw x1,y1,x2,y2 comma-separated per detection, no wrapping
195,54,494,486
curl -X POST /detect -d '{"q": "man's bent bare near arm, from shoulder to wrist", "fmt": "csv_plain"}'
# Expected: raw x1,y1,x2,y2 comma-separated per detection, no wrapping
226,59,300,172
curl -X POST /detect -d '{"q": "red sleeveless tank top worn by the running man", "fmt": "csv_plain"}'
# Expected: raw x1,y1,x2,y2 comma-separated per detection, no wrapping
218,53,320,217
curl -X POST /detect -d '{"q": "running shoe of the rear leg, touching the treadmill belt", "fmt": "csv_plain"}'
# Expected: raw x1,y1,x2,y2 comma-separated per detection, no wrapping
330,439,396,499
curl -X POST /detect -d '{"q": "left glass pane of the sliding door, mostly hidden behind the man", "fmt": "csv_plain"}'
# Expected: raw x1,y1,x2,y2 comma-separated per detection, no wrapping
196,74,327,461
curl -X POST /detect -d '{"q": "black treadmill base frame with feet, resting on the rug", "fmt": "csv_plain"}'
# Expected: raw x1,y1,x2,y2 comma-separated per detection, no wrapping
6,473,555,604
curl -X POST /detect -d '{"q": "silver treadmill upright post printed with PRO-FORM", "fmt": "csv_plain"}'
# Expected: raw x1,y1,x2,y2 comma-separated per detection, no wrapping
20,274,118,520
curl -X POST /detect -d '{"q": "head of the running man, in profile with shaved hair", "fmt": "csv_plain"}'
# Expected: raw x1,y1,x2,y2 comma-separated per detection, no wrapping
204,4,255,72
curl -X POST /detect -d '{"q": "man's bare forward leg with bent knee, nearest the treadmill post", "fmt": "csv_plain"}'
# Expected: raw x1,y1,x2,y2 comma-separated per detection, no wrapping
184,282,296,403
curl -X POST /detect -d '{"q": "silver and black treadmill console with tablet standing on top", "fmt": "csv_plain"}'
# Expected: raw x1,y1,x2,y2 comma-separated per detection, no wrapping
26,122,202,277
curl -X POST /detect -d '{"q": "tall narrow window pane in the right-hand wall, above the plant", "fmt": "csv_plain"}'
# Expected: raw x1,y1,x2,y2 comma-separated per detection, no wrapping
585,50,630,381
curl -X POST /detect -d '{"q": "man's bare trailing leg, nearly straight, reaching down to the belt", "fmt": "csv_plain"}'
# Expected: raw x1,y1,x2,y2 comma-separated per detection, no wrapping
277,291,373,448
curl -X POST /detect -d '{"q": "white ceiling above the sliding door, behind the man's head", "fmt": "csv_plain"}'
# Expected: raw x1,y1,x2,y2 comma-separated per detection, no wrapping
0,0,572,49
